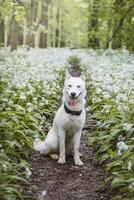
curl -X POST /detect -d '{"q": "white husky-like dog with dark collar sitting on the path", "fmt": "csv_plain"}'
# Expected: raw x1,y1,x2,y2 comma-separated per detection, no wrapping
34,74,86,165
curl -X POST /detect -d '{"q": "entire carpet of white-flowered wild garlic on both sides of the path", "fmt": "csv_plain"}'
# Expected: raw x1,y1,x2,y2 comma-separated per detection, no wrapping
0,48,134,200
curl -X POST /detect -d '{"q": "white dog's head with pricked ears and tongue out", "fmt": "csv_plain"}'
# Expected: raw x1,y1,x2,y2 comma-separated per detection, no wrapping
63,74,86,106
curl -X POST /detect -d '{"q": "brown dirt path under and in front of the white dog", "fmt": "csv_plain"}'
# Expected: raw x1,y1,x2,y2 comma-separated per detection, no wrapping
25,116,109,200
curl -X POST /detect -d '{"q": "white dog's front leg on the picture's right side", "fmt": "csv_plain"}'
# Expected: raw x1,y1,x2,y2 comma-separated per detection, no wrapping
74,130,83,166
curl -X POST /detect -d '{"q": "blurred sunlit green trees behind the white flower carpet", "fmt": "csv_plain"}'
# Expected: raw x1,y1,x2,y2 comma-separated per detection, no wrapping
0,0,134,51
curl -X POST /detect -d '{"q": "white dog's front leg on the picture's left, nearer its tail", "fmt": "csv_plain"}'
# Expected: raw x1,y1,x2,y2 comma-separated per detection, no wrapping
58,129,65,164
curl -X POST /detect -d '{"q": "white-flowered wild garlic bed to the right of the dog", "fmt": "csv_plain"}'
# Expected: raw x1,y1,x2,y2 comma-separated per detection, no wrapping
85,51,134,200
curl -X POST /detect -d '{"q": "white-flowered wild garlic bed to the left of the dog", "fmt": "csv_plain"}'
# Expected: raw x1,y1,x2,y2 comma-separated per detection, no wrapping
0,48,63,200
